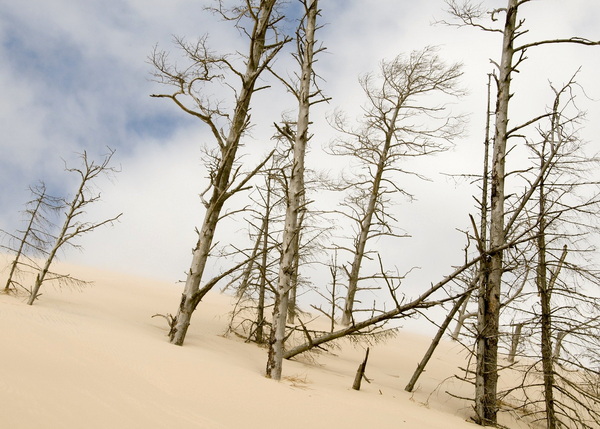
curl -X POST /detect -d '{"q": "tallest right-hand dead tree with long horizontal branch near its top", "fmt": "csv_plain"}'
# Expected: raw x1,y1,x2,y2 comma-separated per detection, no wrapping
446,0,600,425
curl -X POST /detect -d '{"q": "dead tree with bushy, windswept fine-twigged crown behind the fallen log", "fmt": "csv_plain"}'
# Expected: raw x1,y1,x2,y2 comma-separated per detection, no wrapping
331,47,462,326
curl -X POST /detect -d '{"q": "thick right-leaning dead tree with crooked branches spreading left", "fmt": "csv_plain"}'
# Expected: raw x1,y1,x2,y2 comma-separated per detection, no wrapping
150,0,289,345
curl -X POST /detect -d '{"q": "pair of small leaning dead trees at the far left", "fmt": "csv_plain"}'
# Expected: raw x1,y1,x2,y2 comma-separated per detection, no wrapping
0,149,122,305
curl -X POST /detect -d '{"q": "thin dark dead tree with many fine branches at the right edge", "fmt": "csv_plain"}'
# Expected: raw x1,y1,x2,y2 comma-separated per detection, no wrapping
502,78,600,429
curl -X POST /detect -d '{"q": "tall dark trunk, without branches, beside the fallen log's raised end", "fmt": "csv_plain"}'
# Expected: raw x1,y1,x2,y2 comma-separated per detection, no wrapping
475,0,519,425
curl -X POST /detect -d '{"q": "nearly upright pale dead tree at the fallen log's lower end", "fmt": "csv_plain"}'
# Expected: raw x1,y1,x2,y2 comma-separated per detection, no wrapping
266,0,324,380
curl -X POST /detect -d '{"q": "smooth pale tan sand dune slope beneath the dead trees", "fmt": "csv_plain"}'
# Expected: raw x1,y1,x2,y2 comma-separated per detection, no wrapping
0,261,525,429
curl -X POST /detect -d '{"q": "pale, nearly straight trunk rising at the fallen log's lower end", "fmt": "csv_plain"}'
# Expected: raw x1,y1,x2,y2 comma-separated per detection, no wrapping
266,0,318,380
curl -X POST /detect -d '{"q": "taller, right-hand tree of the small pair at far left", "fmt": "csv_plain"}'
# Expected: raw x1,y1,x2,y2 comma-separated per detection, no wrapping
27,150,122,305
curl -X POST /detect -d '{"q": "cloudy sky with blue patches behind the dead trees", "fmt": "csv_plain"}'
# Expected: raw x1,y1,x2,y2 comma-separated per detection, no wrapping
0,0,600,314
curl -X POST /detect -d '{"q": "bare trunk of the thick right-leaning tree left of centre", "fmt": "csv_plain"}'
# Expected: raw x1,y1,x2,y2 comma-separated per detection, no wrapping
169,0,276,346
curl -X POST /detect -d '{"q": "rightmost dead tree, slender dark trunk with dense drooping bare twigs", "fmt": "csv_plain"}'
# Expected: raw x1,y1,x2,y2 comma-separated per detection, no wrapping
510,77,600,429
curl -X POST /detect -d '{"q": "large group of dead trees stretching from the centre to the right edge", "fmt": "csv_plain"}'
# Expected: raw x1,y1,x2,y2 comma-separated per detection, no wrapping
150,0,600,428
